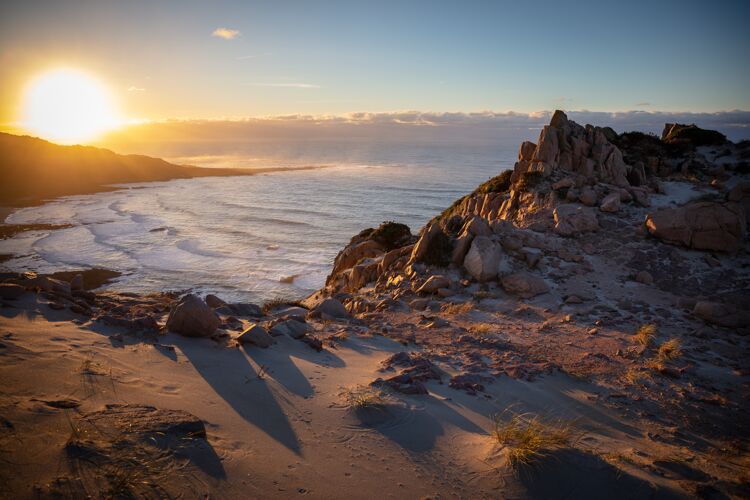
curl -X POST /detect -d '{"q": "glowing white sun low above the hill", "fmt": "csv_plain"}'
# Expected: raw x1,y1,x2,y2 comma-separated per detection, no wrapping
22,68,121,144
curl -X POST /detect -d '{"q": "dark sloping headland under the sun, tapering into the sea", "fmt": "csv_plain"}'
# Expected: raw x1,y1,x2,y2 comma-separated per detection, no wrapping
0,133,258,206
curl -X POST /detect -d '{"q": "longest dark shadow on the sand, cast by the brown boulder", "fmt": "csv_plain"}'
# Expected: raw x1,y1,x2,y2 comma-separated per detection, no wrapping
175,339,300,454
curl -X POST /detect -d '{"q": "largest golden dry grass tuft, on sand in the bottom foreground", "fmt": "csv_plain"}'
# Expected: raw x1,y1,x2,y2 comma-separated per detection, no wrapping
493,410,574,467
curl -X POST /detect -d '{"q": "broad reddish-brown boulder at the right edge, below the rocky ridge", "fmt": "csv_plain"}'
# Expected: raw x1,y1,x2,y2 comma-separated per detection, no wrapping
646,201,746,252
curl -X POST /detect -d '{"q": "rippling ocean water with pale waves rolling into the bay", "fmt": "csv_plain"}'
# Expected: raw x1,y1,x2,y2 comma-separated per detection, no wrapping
0,133,538,303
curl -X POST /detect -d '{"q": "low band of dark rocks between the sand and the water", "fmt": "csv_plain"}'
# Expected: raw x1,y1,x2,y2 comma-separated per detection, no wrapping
0,271,351,351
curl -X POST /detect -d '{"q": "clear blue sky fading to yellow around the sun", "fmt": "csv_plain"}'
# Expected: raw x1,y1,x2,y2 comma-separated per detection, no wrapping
0,0,750,122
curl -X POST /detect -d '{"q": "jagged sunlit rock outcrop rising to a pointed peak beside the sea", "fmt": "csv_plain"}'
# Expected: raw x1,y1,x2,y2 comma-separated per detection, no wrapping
314,111,750,334
